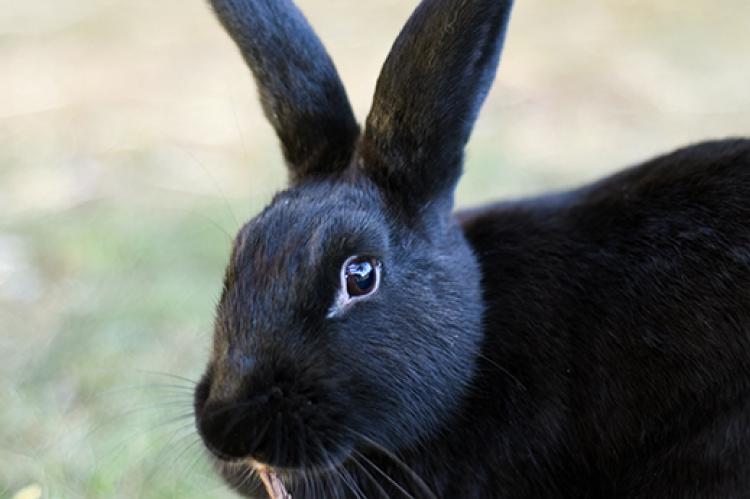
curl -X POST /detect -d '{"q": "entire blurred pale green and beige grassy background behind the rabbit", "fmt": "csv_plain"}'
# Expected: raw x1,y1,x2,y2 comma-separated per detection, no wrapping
0,0,750,498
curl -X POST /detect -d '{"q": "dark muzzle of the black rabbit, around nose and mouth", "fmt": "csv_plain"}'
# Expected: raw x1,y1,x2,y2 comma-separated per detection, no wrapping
195,357,332,468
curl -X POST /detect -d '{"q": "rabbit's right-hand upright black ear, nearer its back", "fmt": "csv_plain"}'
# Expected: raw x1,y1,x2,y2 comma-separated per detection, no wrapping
357,0,513,215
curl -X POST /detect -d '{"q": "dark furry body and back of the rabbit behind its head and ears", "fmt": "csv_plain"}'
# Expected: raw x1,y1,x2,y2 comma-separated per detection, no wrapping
457,140,750,497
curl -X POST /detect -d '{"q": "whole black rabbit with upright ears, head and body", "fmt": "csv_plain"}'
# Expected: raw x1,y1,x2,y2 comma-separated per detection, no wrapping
195,0,750,499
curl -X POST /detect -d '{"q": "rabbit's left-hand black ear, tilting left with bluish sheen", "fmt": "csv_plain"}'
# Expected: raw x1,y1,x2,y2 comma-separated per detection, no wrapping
211,0,359,182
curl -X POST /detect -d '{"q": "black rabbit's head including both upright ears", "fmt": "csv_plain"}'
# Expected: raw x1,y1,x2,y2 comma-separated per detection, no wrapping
195,0,510,483
